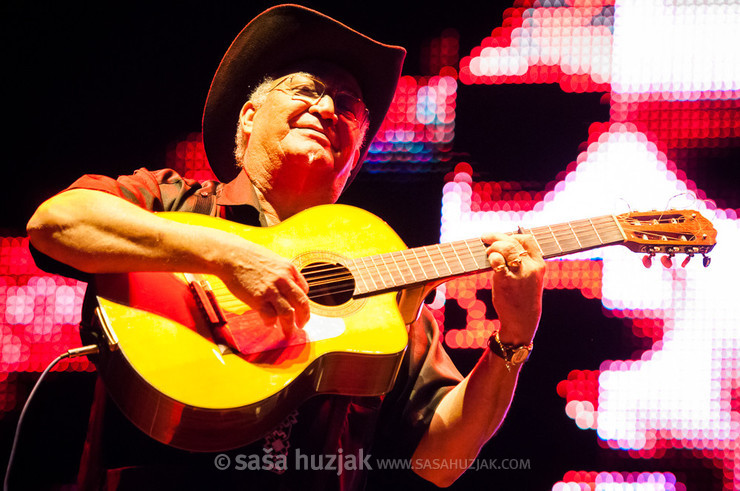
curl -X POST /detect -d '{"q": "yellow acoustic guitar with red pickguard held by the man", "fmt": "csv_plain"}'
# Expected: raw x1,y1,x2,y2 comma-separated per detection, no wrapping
88,205,716,451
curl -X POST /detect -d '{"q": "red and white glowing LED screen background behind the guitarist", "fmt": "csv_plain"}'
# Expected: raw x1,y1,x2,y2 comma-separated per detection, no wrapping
0,0,740,490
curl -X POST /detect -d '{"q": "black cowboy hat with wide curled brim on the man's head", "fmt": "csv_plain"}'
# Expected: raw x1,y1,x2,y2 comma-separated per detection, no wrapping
203,5,406,182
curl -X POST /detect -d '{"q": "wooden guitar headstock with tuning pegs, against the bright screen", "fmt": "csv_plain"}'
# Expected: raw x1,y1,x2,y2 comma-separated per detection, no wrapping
616,210,717,266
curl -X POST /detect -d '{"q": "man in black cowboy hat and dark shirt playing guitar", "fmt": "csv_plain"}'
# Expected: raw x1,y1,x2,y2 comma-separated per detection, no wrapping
28,5,544,489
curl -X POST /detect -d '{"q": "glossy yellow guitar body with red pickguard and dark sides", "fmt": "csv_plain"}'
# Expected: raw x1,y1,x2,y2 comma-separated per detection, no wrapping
95,205,407,451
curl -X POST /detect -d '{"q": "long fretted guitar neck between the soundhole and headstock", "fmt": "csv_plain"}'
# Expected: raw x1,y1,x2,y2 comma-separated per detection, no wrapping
347,215,626,297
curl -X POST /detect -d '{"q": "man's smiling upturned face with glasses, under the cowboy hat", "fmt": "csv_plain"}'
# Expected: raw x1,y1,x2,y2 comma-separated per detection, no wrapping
242,64,367,205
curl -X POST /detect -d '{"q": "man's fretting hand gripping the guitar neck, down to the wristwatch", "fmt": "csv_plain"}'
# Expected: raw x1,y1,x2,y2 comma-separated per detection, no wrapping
481,233,545,345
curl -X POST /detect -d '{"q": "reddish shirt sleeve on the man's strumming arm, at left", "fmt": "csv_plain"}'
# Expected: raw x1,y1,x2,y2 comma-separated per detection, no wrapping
29,168,218,276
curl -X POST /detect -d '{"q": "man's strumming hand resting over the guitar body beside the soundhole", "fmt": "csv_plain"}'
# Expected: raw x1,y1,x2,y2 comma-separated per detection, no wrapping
219,244,311,337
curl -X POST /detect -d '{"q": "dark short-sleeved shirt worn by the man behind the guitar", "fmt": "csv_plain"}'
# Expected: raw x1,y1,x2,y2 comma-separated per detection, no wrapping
33,169,462,490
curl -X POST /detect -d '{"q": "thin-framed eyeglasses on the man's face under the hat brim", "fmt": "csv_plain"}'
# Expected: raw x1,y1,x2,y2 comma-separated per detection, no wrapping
270,74,370,127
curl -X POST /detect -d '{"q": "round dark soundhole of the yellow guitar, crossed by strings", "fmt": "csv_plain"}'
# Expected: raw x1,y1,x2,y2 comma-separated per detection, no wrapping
301,262,355,306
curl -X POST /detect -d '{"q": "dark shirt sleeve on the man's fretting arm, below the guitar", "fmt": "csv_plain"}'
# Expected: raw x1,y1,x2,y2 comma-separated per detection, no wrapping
377,307,463,458
